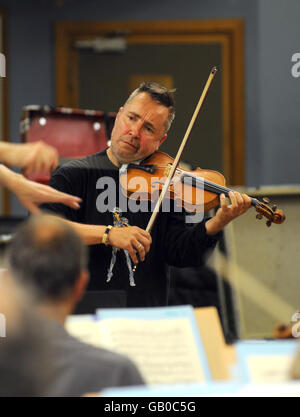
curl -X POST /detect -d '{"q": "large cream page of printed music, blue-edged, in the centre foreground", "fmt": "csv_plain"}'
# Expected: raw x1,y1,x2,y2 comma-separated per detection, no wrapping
98,318,205,384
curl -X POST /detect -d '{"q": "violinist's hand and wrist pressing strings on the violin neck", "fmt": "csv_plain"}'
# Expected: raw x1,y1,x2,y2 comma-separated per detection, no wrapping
205,191,251,235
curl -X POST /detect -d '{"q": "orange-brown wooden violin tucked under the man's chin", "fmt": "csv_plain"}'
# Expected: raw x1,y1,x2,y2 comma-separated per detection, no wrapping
120,151,285,227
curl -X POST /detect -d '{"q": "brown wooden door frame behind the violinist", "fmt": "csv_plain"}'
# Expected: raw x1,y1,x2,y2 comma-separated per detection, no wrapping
55,19,245,185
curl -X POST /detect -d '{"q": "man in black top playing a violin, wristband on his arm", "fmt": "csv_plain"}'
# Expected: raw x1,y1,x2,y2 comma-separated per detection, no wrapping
43,83,251,307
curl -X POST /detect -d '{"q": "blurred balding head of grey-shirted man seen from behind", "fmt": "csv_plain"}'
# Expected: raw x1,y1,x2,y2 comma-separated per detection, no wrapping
7,215,87,301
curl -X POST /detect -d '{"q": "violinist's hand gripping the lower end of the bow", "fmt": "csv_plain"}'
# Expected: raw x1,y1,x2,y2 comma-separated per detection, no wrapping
108,226,152,264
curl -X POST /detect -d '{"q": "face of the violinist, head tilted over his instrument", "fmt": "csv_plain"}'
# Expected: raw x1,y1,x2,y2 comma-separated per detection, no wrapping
109,92,169,163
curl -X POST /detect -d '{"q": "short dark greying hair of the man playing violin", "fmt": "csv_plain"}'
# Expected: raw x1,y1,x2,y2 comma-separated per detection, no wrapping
125,81,175,132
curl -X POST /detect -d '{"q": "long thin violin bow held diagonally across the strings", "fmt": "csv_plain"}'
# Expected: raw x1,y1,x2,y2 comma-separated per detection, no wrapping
146,67,217,233
